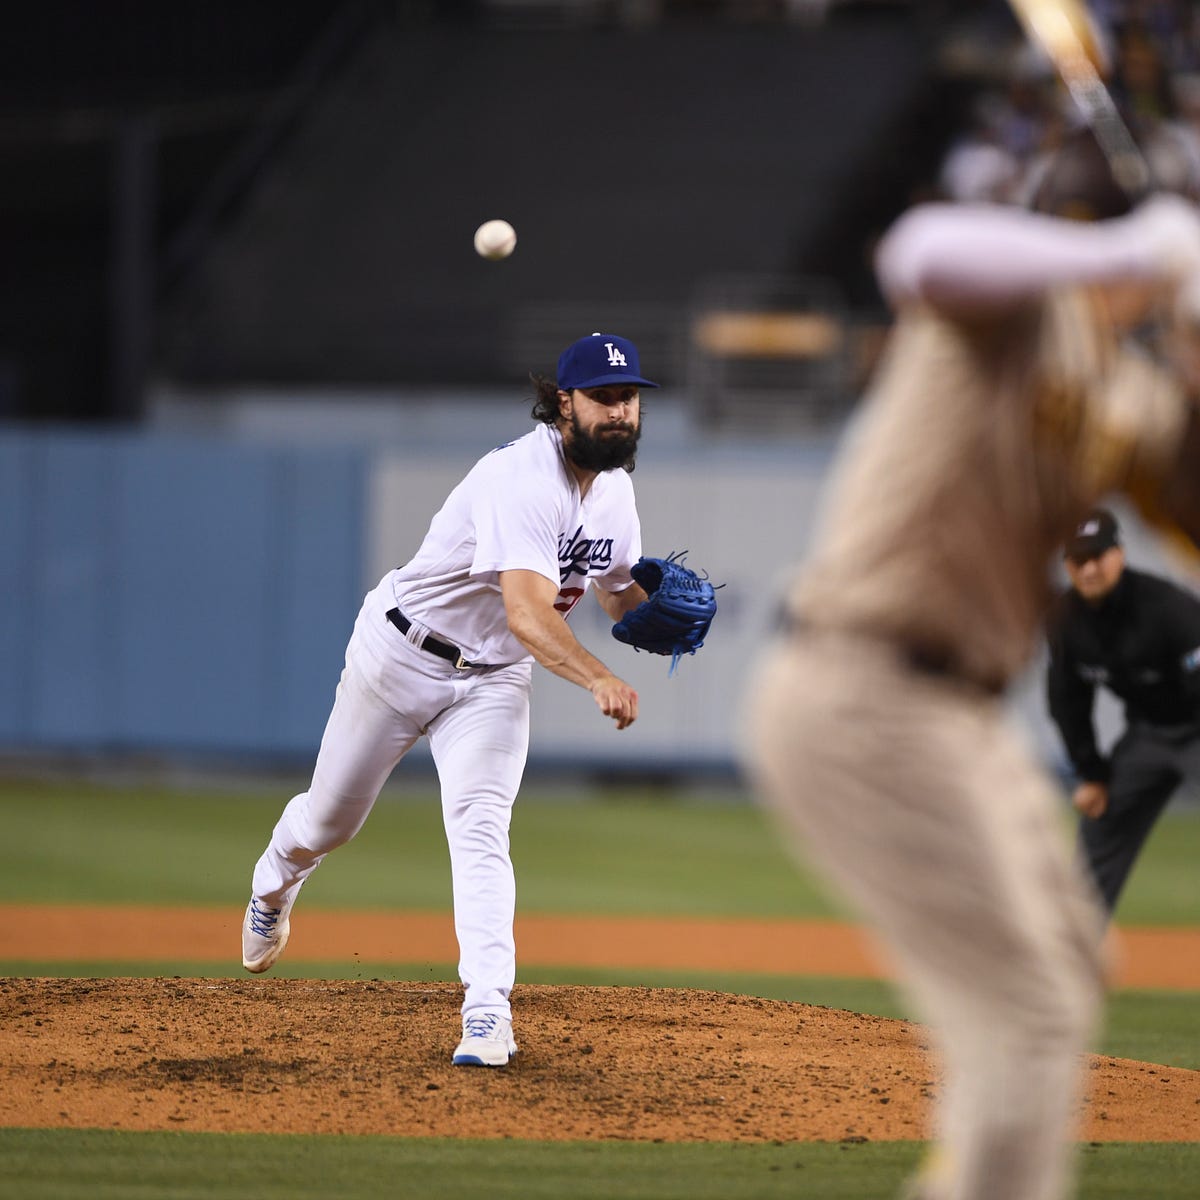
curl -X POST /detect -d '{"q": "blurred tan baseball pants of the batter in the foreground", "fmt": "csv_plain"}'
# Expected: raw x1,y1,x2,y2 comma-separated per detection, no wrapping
745,631,1104,1200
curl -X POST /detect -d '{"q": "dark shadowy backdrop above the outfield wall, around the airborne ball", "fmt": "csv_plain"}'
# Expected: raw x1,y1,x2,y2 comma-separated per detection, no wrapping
0,0,1008,422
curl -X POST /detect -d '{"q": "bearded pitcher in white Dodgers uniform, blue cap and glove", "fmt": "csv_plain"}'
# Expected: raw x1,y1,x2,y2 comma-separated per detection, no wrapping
242,334,716,1067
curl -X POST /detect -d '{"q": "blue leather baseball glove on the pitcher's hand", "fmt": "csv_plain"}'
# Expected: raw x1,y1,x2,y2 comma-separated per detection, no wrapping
612,551,724,673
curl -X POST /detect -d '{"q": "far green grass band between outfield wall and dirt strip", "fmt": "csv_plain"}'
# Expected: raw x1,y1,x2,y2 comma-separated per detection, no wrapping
0,782,1200,925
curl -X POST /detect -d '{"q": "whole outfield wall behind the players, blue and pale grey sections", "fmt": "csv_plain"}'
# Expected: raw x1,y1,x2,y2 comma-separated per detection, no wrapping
0,428,1172,774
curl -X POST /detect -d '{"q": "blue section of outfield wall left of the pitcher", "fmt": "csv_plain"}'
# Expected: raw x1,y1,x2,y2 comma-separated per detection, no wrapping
0,431,366,756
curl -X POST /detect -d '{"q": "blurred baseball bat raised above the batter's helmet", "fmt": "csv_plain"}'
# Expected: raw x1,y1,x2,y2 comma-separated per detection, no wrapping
1008,0,1151,200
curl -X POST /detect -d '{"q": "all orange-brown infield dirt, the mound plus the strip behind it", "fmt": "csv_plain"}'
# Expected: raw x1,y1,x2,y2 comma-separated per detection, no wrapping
0,908,1200,1141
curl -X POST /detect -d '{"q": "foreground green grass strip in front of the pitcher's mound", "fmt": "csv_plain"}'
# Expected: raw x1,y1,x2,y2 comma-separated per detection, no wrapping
0,1129,1200,1200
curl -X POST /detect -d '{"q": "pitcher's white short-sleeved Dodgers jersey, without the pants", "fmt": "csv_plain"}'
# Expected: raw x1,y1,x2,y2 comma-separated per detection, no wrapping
391,425,642,664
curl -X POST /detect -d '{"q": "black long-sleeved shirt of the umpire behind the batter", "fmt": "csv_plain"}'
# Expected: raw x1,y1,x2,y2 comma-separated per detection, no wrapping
1046,566,1200,782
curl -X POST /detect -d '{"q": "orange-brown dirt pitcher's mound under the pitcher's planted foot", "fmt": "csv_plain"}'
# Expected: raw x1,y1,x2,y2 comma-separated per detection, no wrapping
0,979,1200,1141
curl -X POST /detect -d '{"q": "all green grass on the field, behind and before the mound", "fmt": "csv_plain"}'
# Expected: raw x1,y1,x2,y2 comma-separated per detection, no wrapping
0,782,1200,1200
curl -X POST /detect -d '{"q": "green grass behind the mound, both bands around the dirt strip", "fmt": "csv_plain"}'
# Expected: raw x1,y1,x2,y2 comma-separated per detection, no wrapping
7,781,1200,1068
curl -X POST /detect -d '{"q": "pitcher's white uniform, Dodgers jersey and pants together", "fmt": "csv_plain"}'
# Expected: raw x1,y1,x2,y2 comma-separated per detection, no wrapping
253,425,642,1019
